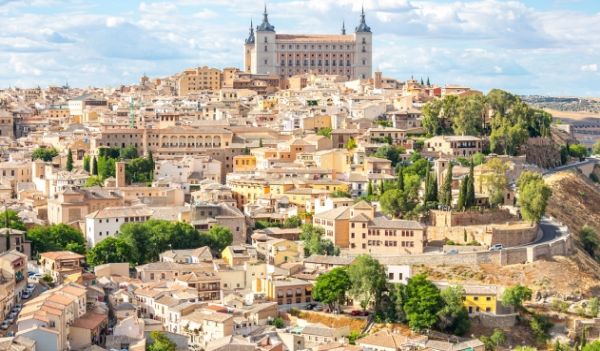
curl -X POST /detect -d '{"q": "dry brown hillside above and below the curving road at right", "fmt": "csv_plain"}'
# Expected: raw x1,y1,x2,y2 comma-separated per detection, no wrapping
415,172,600,297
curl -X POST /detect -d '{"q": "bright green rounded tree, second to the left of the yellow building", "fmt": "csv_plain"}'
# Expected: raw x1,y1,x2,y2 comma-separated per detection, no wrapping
404,274,444,331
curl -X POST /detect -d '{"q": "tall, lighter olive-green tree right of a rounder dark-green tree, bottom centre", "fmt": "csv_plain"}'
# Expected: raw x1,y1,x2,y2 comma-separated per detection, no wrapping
348,255,387,310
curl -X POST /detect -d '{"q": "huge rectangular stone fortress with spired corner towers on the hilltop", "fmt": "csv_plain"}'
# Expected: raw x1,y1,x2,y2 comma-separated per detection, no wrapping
244,8,373,79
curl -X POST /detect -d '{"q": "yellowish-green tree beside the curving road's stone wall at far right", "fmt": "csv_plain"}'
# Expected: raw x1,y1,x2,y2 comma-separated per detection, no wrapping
517,171,552,222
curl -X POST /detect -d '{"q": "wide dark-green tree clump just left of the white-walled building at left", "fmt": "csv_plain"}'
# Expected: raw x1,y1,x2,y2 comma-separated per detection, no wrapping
27,224,85,256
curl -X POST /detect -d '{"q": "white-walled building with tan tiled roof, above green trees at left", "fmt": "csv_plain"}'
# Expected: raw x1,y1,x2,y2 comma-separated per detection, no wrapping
85,206,153,247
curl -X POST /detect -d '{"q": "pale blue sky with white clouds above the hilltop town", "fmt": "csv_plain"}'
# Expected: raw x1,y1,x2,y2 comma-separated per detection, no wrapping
0,0,600,97
